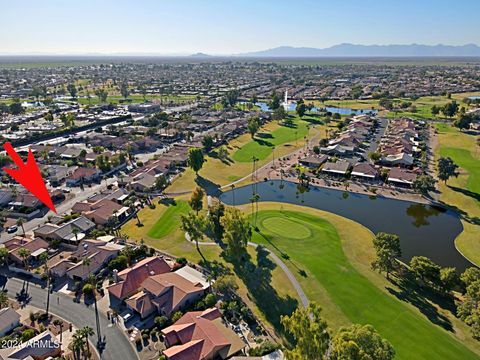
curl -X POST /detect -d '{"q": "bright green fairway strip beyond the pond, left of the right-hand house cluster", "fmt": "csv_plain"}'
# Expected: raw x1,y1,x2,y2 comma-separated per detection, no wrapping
233,118,308,162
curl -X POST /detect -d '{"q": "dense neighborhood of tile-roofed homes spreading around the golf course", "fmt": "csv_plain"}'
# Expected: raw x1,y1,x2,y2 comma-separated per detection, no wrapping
0,58,480,360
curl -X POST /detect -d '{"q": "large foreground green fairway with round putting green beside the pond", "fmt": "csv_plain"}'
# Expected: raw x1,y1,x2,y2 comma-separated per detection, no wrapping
253,210,478,359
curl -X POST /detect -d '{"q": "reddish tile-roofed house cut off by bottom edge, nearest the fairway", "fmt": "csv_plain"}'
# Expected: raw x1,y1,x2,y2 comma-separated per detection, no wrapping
162,308,245,360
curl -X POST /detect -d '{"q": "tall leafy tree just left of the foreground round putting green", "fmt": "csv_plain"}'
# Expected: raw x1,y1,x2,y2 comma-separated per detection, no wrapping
220,208,252,259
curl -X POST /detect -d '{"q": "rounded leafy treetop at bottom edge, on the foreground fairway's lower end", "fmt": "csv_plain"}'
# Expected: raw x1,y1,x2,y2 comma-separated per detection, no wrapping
329,324,395,360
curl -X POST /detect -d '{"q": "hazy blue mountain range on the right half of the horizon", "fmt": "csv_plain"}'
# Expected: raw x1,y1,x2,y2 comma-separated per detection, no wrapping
236,44,480,57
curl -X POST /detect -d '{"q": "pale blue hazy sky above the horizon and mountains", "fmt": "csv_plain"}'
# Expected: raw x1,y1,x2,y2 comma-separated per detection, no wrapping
0,0,480,54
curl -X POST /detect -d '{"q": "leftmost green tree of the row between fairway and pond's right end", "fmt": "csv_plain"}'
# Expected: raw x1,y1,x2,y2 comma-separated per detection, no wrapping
372,232,402,279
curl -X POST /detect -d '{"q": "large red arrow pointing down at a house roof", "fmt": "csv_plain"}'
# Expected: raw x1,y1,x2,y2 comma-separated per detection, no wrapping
3,142,57,214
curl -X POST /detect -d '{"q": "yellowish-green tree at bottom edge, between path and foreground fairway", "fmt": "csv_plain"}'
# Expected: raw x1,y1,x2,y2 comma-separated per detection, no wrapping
280,302,330,360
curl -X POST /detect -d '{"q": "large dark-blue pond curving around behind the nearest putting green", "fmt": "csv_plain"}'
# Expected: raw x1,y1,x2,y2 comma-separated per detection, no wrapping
220,180,472,271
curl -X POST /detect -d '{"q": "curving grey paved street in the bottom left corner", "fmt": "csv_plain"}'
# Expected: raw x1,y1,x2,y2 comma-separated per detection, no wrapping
5,278,138,360
